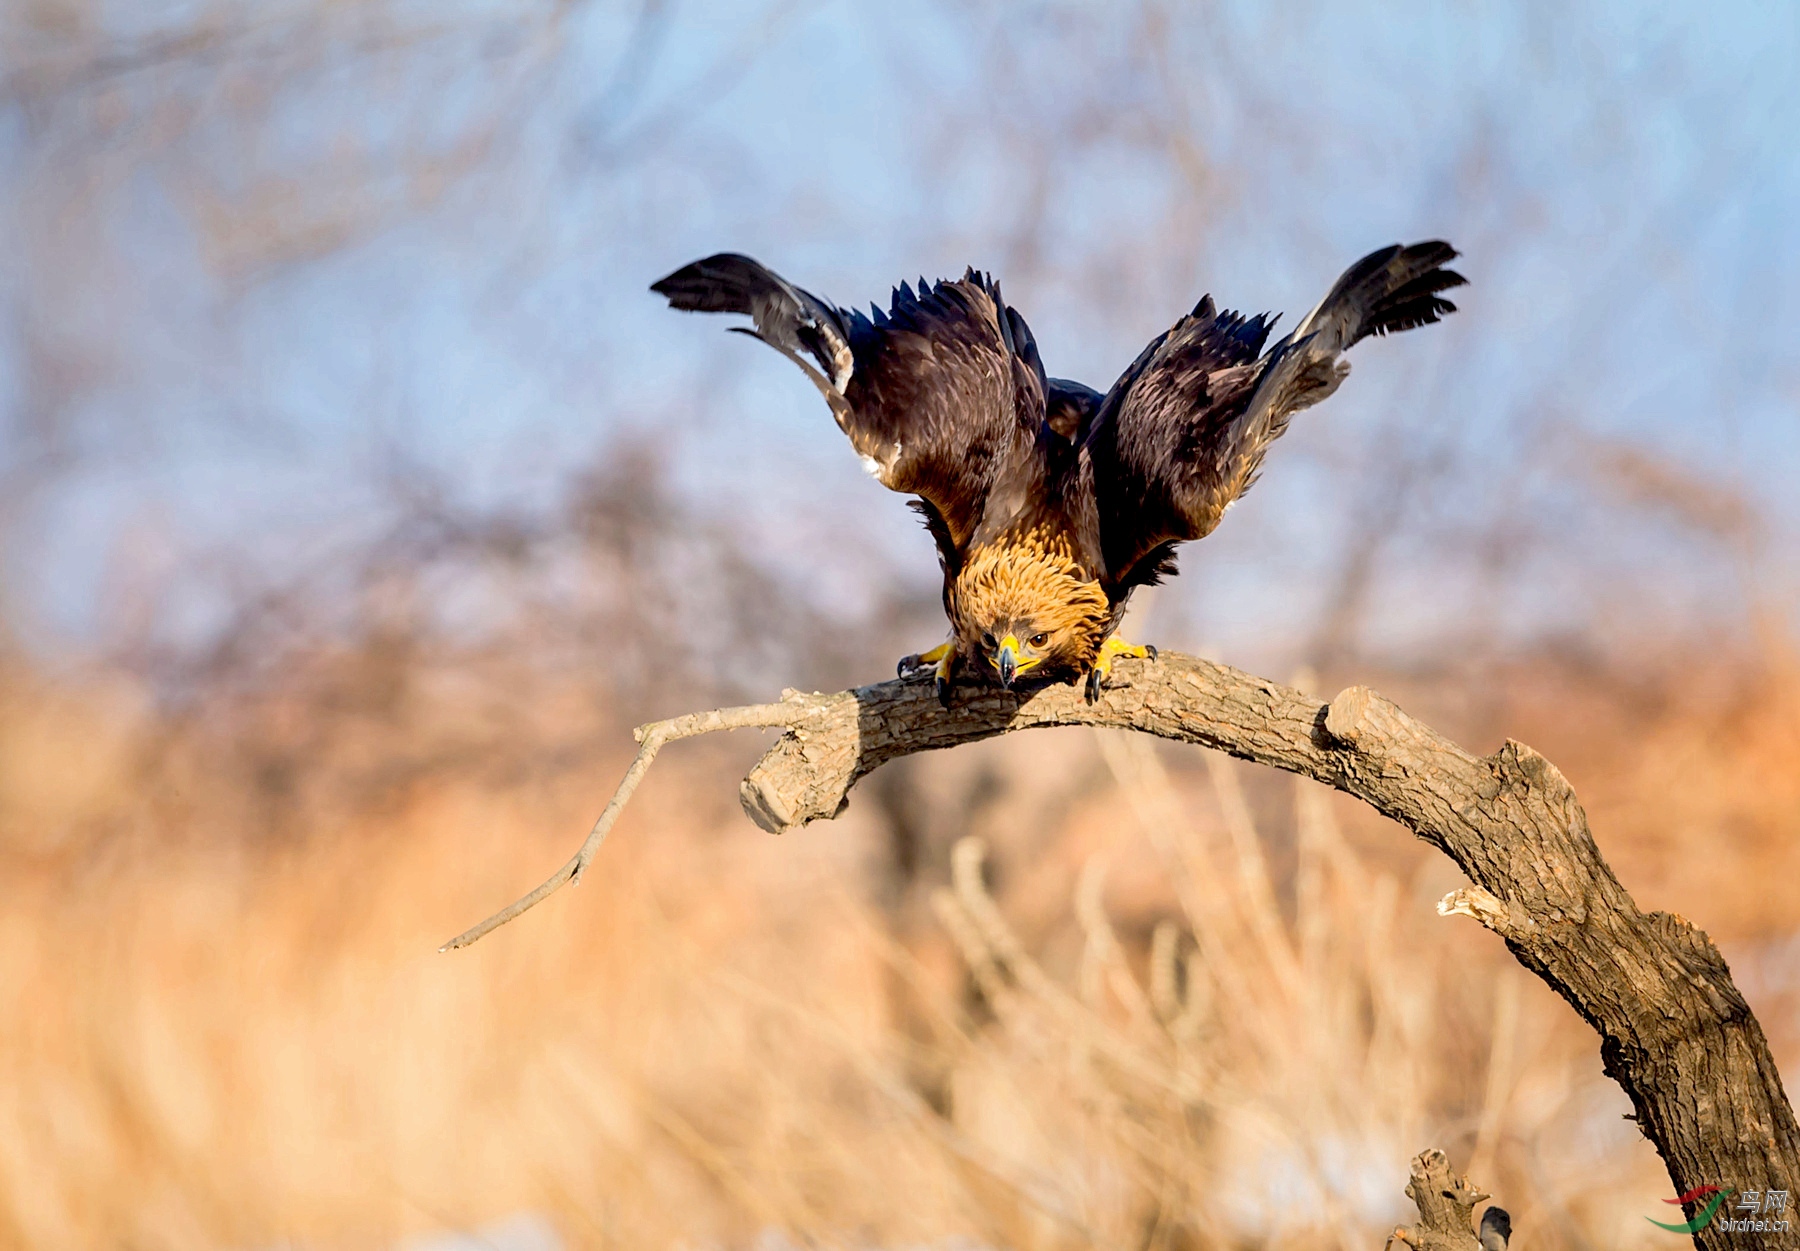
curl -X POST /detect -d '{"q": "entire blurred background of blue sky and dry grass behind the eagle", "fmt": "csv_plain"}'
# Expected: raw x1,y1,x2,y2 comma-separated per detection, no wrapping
0,0,1800,1251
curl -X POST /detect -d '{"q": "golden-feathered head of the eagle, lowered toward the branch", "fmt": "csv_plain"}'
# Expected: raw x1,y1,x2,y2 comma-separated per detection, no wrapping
950,531,1112,686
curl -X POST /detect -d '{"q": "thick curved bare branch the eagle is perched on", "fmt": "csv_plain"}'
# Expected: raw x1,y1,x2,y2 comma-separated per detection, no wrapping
446,652,1800,1249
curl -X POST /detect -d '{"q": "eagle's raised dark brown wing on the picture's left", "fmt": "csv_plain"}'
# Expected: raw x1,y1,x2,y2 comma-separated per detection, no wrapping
650,252,1044,567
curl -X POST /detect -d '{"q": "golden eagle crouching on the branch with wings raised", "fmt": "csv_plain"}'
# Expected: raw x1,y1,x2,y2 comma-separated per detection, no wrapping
650,241,1463,704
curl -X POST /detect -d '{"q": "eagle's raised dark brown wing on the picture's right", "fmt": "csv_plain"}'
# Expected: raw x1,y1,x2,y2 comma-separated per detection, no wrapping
1085,241,1463,598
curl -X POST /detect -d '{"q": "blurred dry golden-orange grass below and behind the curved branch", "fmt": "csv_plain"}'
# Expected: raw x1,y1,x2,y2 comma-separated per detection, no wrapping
0,630,1800,1251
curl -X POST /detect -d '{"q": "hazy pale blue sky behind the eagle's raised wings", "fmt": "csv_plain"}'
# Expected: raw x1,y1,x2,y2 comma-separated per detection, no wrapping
0,0,1800,666
